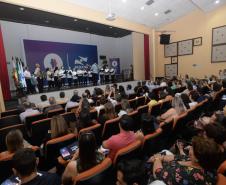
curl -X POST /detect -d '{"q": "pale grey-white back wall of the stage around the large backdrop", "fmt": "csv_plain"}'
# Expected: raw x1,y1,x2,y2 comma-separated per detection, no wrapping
0,21,133,90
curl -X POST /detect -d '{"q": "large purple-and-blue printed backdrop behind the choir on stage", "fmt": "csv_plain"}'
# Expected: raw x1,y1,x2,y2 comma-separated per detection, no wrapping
23,40,98,72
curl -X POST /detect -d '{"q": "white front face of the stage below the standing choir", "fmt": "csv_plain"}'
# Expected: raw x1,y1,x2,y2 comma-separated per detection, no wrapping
28,81,138,104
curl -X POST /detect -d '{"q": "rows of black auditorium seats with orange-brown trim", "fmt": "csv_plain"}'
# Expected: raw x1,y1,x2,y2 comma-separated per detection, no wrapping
0,81,226,185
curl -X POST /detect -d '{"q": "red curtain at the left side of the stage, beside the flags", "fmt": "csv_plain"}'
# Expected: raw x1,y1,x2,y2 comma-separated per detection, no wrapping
0,25,11,100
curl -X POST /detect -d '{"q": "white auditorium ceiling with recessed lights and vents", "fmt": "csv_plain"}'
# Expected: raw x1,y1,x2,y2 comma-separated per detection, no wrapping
64,0,226,28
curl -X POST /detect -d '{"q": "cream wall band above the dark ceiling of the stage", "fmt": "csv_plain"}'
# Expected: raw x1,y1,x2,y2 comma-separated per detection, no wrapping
1,0,152,34
